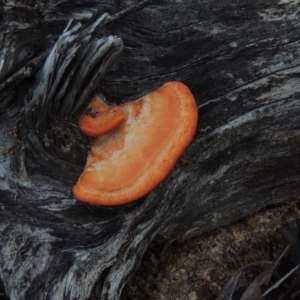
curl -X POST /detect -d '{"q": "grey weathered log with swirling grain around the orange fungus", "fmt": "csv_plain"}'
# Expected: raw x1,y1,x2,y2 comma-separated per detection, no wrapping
0,0,300,300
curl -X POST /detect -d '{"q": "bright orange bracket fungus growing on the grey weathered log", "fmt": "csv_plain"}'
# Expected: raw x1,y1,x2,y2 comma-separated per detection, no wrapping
73,82,198,206
